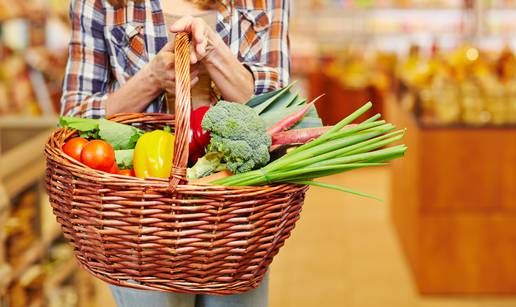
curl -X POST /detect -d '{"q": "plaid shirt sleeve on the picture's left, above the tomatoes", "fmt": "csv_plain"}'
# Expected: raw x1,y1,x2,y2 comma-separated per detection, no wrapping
61,0,109,118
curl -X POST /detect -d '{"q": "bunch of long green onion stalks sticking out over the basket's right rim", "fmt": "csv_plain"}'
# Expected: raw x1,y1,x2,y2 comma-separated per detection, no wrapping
212,102,407,199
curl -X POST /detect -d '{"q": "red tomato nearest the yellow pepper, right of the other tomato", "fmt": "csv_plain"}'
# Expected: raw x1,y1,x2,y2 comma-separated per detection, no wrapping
81,140,115,172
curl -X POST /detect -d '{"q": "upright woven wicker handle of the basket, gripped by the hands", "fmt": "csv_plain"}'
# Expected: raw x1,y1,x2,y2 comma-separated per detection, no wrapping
169,32,192,191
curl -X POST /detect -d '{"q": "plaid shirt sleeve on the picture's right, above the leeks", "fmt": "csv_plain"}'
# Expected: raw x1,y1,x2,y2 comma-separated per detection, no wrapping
244,0,290,95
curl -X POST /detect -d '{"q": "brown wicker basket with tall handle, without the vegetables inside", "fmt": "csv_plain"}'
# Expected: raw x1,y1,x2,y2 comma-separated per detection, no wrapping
45,33,308,295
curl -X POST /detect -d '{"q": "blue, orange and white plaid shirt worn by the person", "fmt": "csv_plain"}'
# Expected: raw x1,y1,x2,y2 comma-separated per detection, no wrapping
61,0,290,118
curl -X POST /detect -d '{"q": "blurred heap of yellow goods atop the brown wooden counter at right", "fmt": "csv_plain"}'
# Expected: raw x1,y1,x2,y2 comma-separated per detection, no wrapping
398,45,516,126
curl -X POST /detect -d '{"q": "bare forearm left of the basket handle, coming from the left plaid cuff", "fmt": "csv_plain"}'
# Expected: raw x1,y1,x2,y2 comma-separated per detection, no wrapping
105,65,162,116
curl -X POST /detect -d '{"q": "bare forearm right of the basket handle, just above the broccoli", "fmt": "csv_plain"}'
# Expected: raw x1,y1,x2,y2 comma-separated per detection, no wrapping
203,38,254,103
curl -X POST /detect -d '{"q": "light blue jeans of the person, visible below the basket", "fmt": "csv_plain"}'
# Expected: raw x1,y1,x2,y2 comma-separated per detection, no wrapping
109,274,269,307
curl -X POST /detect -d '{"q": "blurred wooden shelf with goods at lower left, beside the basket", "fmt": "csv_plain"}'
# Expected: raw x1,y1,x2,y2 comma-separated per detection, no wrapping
0,116,96,307
